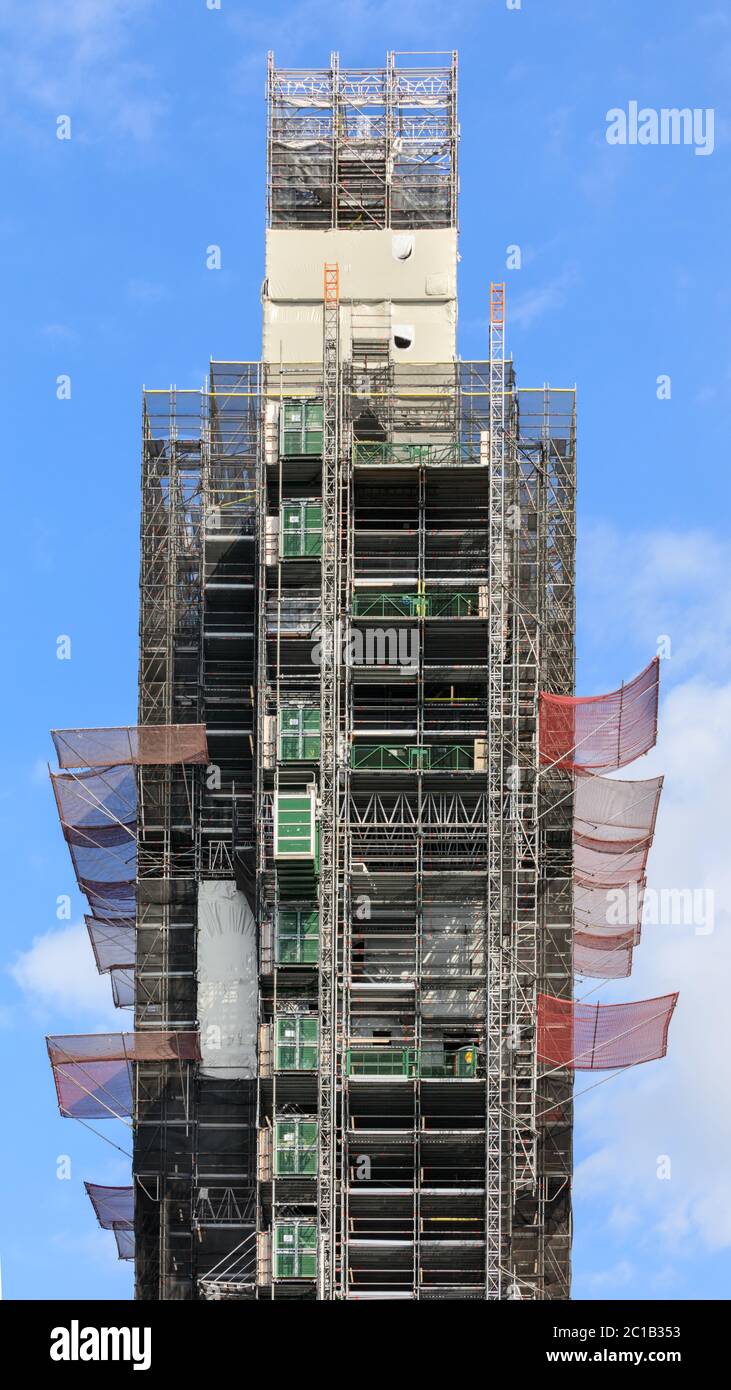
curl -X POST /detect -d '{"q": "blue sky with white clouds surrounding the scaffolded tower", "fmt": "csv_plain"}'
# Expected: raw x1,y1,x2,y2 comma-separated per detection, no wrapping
0,0,731,1298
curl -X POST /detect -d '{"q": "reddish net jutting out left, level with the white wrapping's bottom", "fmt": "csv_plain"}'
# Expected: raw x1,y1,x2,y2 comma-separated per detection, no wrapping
46,1033,200,1119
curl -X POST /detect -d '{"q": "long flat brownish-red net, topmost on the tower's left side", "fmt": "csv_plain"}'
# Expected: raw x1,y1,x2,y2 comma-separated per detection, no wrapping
51,724,208,767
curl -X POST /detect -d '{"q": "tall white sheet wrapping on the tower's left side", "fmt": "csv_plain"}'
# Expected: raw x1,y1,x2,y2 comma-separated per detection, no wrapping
197,880,258,1080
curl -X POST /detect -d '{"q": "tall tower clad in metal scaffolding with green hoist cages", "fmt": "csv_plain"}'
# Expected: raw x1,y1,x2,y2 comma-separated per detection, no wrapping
133,54,575,1301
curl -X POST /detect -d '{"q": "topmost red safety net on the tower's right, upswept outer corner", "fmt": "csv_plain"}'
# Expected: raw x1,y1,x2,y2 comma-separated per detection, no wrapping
539,656,660,771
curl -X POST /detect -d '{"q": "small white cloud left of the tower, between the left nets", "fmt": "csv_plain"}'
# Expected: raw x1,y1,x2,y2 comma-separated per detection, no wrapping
10,923,116,1029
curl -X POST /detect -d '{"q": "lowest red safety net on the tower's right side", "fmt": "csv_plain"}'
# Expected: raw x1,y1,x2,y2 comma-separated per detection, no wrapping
538,994,678,1072
